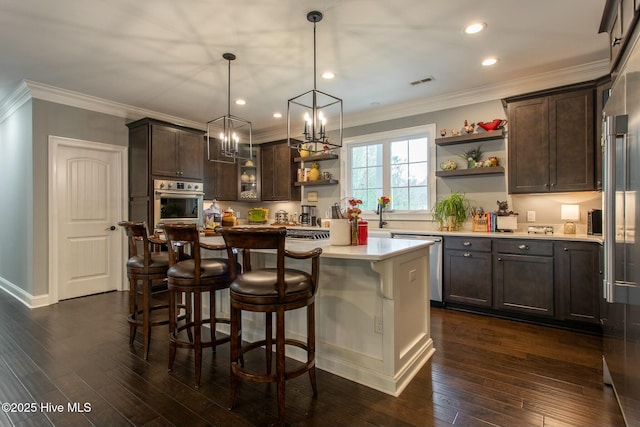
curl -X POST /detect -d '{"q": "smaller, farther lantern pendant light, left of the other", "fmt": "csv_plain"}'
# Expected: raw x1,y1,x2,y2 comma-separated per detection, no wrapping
206,53,253,163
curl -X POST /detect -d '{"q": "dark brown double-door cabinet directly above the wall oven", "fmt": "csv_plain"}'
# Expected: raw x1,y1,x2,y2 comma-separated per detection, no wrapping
128,118,204,181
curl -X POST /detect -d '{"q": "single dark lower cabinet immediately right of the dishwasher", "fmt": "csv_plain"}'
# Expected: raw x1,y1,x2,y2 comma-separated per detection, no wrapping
443,237,492,307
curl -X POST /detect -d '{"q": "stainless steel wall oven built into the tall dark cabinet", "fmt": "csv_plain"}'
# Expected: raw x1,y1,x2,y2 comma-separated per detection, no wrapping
153,179,204,229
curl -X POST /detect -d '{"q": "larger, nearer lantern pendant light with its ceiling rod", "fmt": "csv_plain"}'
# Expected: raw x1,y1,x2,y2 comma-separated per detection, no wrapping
287,10,342,155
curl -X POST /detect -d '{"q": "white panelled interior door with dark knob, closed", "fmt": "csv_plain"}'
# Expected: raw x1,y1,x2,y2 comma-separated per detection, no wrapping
49,136,126,302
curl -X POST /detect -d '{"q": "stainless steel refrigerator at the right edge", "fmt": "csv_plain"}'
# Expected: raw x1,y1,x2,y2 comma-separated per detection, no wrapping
602,26,640,426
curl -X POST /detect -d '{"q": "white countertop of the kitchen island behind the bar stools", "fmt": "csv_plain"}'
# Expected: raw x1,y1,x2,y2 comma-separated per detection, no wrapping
200,236,433,261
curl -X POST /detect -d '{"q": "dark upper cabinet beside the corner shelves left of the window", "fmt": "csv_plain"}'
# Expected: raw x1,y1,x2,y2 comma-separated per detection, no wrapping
260,140,300,201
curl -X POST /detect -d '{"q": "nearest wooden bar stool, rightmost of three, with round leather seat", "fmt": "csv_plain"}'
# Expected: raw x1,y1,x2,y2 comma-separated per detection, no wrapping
221,227,322,424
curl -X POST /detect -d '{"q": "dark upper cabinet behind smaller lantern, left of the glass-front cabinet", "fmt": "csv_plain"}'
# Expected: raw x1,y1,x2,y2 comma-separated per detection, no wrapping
203,138,238,201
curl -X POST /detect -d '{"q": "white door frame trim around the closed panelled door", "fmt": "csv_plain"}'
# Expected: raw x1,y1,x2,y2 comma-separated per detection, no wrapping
47,135,129,304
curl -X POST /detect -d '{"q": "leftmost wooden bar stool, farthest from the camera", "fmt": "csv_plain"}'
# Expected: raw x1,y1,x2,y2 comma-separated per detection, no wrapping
118,221,169,359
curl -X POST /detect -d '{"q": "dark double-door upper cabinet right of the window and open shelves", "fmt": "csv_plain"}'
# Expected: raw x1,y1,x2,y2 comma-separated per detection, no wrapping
505,82,595,194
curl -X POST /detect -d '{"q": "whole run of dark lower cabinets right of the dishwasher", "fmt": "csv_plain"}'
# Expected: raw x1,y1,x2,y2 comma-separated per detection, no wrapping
443,236,600,328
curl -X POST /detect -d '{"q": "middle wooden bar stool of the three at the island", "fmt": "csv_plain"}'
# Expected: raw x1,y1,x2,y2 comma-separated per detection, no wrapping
158,224,235,387
